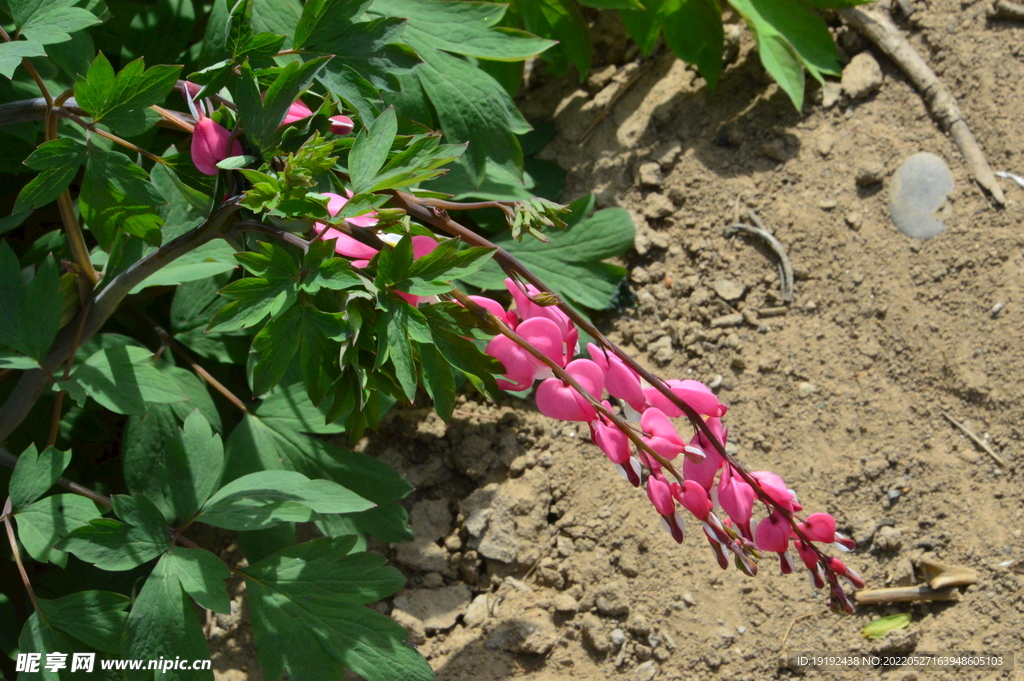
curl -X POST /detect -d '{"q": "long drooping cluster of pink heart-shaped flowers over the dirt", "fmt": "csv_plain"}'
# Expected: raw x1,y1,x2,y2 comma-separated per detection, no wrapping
470,279,864,610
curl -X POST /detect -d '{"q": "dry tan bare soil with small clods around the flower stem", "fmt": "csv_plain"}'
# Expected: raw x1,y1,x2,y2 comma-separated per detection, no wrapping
216,0,1024,681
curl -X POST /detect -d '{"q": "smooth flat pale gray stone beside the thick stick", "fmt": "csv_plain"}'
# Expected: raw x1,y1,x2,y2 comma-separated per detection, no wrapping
889,153,953,239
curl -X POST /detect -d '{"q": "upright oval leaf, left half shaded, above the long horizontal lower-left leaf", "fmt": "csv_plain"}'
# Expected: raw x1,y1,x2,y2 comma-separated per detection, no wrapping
165,410,224,522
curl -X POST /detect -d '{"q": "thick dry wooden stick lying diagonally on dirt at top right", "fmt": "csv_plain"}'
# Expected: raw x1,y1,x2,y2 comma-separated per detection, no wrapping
839,7,1007,206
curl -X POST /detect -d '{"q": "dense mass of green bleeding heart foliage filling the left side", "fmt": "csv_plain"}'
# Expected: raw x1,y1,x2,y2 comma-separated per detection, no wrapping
0,0,638,681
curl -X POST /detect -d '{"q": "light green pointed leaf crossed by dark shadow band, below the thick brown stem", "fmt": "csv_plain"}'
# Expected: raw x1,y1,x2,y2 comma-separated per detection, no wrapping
61,345,187,414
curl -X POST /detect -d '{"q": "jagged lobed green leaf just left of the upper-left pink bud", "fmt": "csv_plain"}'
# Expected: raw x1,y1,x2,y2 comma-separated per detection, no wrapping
75,52,181,123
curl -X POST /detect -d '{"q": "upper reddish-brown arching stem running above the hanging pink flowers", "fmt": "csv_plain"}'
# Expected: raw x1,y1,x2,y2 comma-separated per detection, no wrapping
390,191,824,561
